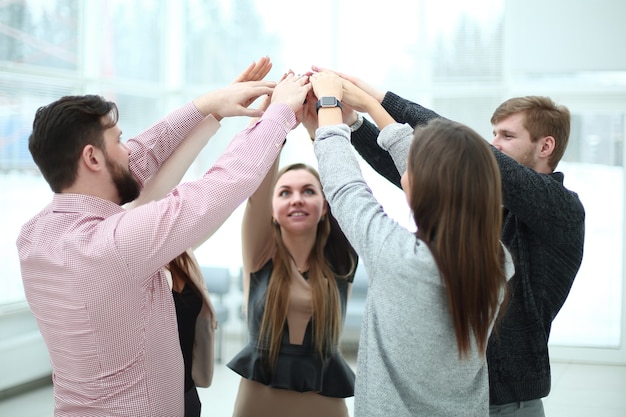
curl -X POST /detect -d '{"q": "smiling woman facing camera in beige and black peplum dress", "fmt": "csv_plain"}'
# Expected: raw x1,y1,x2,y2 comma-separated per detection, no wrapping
228,154,357,417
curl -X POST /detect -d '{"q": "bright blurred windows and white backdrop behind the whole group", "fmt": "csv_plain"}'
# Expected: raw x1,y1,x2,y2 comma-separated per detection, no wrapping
0,0,626,404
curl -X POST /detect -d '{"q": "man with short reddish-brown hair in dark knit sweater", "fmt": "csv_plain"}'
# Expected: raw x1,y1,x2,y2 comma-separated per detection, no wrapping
313,67,585,417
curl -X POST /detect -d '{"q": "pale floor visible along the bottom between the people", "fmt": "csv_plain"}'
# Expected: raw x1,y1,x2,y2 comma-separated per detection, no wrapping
0,336,626,417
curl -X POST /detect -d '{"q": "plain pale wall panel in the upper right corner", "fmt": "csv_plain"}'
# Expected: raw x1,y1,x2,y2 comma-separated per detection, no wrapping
505,0,626,73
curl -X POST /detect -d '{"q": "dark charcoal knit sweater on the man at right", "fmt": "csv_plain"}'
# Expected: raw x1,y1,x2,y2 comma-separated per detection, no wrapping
351,92,585,405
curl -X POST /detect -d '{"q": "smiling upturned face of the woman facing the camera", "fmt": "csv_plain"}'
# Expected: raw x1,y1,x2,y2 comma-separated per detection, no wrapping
272,169,326,234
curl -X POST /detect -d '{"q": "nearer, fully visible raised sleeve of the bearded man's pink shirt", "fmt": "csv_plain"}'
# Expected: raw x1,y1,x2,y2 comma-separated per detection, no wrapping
117,104,296,282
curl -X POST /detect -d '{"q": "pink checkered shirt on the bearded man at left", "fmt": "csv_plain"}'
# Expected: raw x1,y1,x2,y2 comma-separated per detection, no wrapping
17,103,295,417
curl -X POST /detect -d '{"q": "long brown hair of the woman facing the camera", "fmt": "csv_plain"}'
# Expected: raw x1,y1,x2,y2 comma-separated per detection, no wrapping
260,163,357,369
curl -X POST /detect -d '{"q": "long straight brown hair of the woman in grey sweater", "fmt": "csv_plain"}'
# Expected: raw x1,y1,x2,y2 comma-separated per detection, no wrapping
407,119,506,357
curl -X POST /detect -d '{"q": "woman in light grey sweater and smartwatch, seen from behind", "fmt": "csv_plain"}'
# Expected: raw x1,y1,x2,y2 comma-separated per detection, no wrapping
311,72,513,417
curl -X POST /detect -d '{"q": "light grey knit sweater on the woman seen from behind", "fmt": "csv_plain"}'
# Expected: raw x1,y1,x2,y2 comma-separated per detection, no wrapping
315,125,513,417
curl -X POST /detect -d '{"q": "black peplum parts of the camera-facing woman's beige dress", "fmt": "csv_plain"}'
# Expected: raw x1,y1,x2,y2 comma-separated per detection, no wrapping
227,260,354,398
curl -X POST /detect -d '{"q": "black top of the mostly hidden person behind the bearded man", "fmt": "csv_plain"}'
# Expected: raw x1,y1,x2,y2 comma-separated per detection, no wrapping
172,284,202,392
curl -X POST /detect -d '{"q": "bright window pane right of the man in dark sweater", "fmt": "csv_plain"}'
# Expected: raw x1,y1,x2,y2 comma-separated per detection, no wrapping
551,110,626,349
